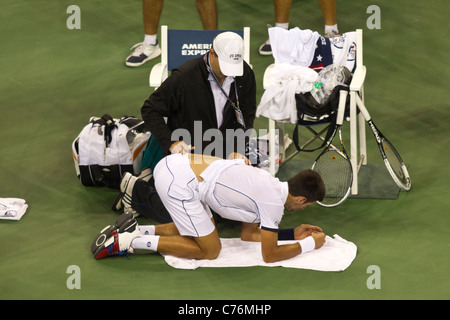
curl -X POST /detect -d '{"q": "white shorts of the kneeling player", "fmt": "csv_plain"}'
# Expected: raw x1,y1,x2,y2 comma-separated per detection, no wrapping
153,153,215,237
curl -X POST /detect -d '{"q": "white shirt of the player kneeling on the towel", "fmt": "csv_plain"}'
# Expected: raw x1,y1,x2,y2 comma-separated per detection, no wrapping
200,160,288,231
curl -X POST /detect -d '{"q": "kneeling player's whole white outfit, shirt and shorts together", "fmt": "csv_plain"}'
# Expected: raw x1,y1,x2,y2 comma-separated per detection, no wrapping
154,154,288,237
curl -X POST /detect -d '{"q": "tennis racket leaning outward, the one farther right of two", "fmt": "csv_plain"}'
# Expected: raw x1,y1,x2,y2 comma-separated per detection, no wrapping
355,94,411,191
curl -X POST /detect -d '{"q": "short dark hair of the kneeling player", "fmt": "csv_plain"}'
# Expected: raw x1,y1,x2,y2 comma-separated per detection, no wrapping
288,169,325,202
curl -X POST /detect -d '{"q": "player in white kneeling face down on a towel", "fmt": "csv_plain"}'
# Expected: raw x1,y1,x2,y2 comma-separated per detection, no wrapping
91,154,325,262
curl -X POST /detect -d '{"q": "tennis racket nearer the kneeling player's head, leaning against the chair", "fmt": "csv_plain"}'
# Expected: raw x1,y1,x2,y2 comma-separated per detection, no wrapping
311,90,353,207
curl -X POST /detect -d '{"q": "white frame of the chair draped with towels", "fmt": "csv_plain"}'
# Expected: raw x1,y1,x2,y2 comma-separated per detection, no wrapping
263,29,367,195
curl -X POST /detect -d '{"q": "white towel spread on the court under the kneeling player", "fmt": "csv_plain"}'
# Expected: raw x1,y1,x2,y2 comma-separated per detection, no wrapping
164,234,357,271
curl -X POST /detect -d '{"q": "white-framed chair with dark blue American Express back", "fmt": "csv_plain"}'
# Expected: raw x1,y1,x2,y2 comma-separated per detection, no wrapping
149,25,251,89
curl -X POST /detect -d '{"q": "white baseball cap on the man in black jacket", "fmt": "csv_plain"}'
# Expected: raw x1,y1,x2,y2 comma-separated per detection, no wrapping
213,31,244,76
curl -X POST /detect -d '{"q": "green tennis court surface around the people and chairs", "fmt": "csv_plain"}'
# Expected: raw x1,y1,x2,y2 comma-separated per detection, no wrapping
0,0,450,300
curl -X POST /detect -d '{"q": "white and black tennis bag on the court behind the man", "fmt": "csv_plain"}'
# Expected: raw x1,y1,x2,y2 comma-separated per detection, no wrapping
72,114,150,189
